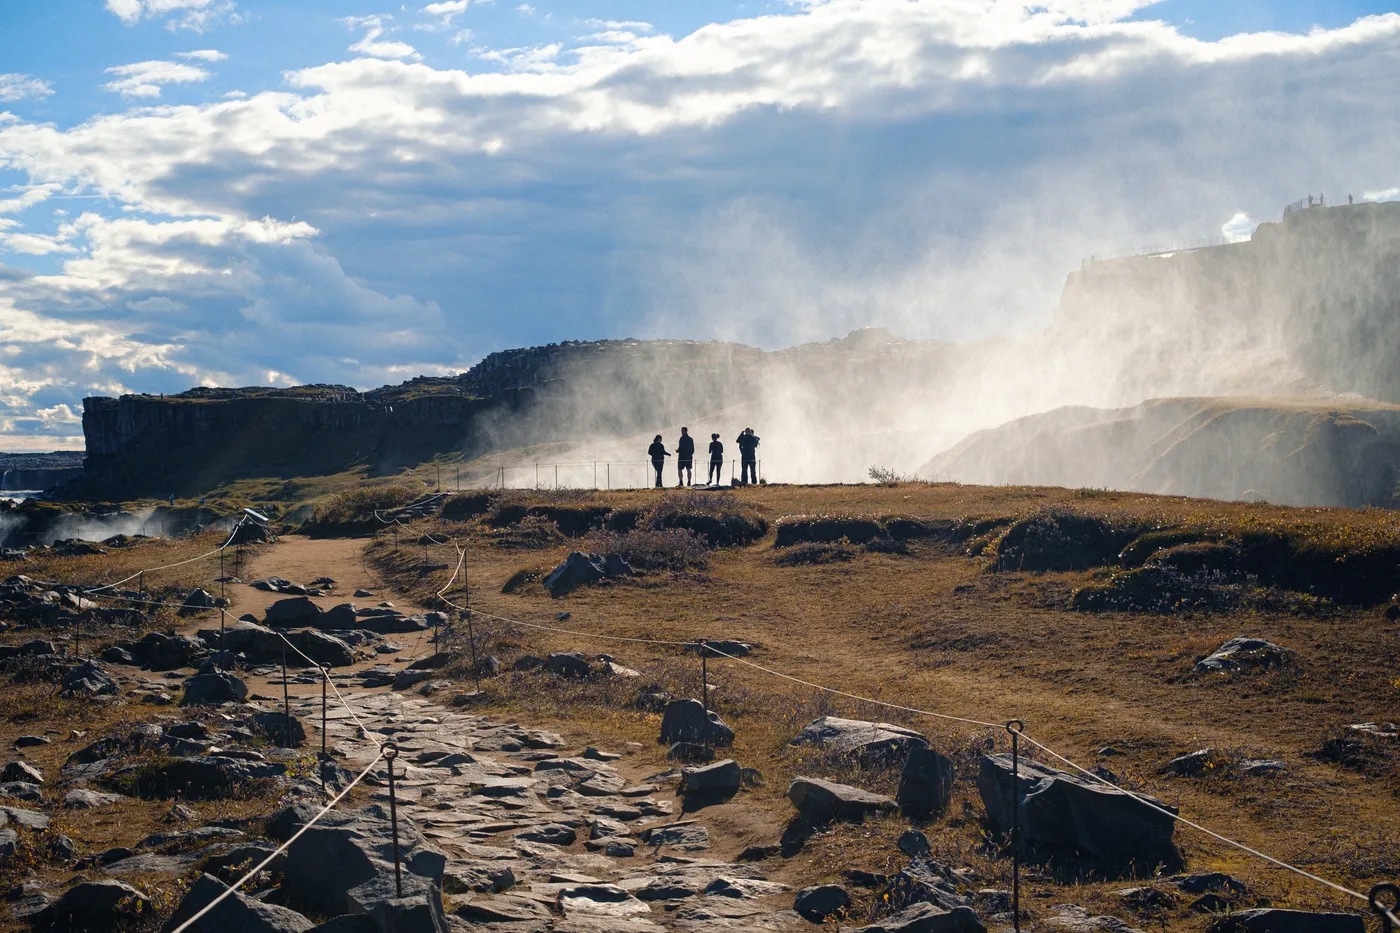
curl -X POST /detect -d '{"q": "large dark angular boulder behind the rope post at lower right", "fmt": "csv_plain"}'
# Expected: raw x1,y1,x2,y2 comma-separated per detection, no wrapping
977,754,1177,864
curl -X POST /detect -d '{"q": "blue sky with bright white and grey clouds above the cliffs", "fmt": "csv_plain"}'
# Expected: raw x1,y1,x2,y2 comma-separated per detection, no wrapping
0,0,1400,450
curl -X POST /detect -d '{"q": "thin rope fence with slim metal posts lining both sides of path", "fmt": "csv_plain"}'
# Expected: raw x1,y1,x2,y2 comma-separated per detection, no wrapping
16,516,1400,933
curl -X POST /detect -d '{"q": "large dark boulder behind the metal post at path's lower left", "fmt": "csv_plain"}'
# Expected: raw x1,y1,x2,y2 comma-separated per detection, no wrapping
283,806,447,916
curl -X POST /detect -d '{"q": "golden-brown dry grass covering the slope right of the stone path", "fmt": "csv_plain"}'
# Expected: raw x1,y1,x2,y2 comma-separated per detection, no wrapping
352,483,1400,929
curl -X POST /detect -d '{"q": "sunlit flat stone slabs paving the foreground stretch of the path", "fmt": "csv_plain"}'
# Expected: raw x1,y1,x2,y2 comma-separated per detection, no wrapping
310,693,812,933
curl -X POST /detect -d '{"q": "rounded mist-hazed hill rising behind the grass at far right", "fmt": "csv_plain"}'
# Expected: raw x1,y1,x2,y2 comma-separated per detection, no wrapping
918,398,1400,507
